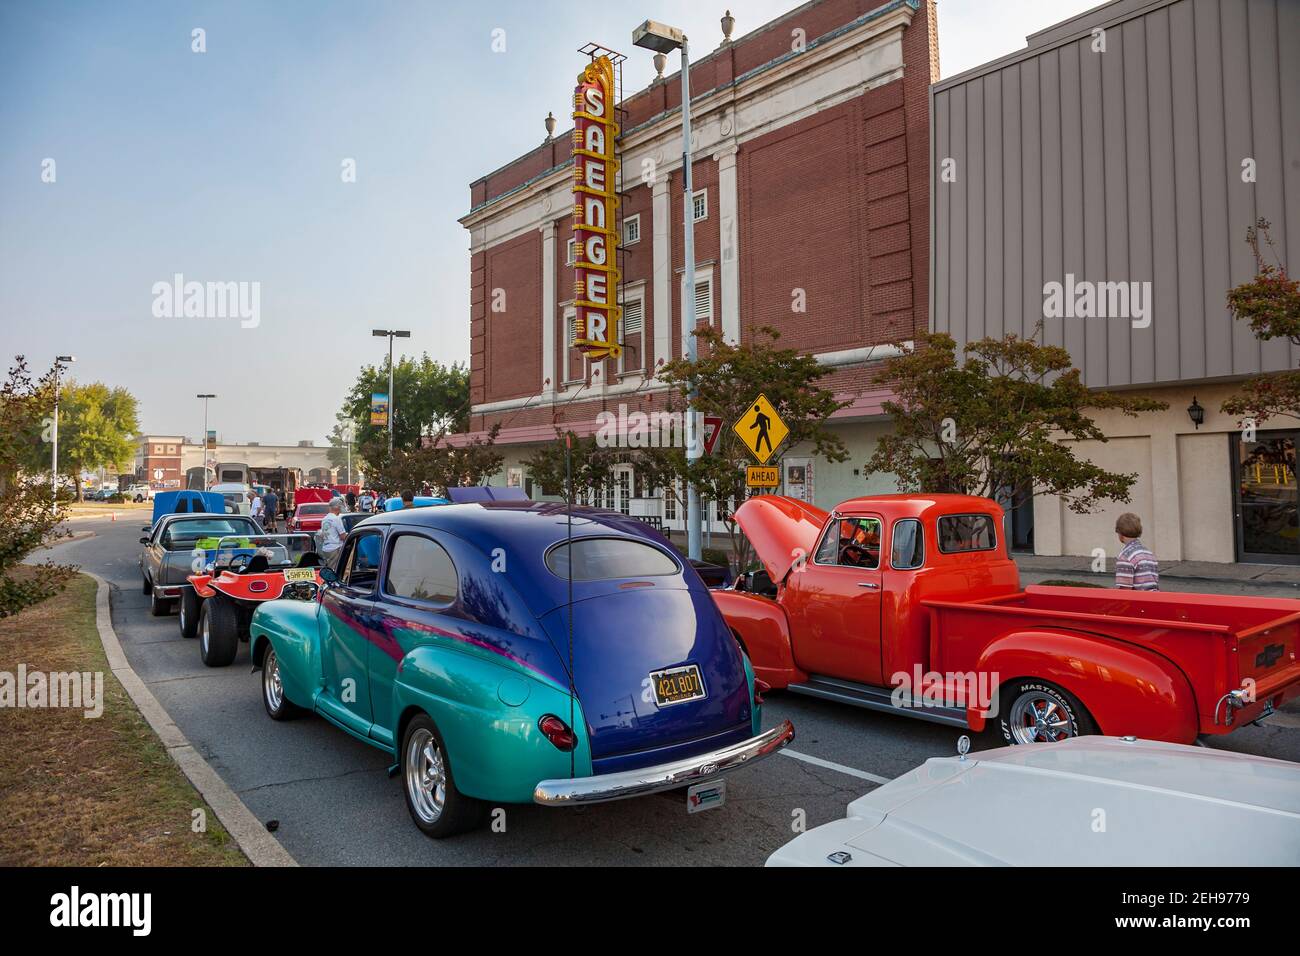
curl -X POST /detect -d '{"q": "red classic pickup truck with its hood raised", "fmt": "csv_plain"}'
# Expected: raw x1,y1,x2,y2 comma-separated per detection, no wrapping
712,494,1300,744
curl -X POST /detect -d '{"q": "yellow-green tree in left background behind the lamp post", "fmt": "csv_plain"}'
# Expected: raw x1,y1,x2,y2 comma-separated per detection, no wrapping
59,382,140,501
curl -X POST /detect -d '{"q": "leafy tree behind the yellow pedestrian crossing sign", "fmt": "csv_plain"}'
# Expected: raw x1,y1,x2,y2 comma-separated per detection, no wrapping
658,325,849,567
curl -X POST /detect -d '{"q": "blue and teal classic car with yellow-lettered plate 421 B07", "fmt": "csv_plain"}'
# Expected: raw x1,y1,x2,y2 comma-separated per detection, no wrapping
250,501,794,838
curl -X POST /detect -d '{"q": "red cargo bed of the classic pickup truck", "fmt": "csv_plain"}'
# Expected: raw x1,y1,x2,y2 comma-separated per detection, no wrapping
922,585,1300,734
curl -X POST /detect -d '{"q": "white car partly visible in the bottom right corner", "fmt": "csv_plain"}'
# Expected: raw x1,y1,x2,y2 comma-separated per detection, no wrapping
767,736,1300,871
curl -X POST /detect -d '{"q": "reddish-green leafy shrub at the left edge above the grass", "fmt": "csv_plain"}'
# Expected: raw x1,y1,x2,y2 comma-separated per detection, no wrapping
0,355,77,618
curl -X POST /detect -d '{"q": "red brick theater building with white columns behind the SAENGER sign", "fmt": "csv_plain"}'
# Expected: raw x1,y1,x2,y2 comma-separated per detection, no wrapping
460,0,939,528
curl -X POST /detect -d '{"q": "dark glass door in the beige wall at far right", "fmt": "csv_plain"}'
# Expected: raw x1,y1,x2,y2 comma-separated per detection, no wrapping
1232,432,1300,564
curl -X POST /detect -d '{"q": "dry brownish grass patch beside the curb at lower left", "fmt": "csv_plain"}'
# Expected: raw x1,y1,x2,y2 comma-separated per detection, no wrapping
0,568,248,866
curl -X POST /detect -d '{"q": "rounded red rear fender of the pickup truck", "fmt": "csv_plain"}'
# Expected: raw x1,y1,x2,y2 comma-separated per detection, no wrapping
967,628,1200,744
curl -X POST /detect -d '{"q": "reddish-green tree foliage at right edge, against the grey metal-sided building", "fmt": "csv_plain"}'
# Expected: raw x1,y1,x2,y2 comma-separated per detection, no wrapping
1222,219,1300,425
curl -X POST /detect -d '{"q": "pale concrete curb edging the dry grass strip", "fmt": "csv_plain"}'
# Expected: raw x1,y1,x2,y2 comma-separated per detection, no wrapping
82,571,298,866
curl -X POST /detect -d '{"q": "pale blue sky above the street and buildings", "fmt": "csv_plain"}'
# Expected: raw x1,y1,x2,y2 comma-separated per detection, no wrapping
0,0,1095,444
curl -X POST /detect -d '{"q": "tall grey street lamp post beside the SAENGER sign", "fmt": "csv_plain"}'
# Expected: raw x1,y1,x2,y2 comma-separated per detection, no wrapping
632,20,703,561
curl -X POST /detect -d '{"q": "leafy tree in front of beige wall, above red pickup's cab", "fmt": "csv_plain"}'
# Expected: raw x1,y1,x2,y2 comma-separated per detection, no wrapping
866,324,1167,514
